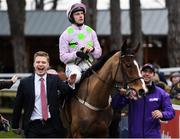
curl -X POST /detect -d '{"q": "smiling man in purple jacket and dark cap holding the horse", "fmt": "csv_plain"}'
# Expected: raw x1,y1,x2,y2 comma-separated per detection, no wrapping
112,64,175,138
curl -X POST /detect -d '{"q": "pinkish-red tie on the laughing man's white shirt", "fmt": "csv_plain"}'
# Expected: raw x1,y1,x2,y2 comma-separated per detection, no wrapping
40,78,48,121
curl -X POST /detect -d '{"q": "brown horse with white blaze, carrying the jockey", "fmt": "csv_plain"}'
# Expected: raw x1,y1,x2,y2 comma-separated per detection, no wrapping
63,41,147,138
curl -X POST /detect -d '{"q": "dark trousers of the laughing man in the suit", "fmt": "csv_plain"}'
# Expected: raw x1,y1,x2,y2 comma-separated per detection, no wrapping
25,119,60,138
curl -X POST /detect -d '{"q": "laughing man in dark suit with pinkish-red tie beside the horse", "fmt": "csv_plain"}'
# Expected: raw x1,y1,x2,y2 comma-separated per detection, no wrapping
12,51,75,138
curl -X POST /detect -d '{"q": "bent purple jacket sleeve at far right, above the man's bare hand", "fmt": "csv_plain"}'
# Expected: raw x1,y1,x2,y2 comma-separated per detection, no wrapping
161,94,175,121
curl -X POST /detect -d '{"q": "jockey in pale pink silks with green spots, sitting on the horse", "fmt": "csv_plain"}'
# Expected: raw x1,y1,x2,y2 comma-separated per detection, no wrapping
59,3,102,83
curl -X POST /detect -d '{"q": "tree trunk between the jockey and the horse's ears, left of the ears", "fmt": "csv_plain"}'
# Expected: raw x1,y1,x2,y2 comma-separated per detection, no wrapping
110,0,122,50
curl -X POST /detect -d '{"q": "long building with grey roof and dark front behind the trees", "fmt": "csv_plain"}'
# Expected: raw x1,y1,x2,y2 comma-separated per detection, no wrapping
0,9,169,73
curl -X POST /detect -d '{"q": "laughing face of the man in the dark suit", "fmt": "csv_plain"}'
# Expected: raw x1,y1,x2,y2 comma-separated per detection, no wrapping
33,56,49,76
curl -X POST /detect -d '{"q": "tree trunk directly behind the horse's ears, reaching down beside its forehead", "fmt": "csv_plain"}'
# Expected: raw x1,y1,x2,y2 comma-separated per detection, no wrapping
130,0,143,65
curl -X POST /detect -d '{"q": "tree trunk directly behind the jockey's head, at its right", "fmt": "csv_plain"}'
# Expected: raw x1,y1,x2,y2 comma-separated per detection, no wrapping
82,0,97,30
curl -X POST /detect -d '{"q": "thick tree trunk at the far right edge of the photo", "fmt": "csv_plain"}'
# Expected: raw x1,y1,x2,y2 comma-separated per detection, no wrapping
166,0,180,67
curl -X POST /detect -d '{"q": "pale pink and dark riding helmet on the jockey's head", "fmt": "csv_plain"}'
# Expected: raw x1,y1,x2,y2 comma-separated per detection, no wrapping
66,3,86,23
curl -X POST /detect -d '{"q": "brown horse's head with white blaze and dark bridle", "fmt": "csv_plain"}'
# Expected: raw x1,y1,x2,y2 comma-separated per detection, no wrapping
120,41,148,98
